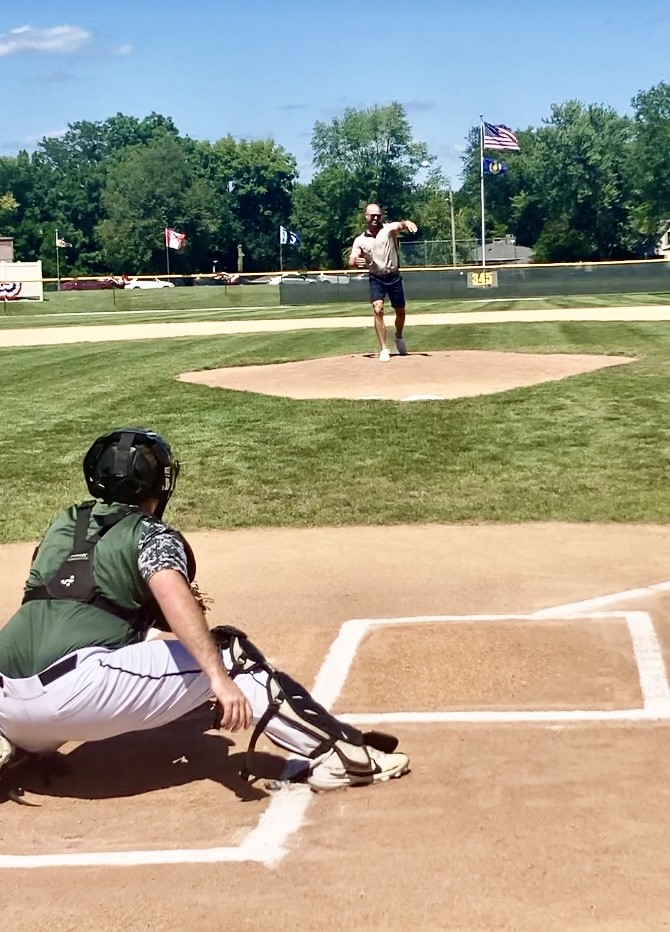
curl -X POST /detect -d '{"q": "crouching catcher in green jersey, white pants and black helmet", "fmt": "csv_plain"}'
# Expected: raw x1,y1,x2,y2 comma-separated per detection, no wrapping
0,427,409,791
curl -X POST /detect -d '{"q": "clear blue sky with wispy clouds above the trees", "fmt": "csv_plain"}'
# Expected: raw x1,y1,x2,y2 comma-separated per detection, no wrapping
0,0,670,187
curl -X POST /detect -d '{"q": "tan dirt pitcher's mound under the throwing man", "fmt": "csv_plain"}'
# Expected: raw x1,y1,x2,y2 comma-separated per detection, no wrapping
179,350,634,401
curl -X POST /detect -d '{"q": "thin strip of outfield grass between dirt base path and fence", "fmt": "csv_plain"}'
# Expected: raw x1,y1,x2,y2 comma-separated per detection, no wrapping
0,294,670,330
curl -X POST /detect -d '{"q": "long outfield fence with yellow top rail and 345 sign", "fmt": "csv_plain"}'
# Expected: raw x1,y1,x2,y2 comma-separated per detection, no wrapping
0,259,670,316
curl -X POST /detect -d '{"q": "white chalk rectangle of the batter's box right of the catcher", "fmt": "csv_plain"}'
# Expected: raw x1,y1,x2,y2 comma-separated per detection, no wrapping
314,611,670,725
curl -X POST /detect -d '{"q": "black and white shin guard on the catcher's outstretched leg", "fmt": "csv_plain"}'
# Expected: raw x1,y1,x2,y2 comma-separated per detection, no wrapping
212,625,398,779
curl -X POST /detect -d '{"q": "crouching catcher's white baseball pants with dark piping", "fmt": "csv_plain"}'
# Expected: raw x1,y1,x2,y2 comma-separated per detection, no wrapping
0,640,326,757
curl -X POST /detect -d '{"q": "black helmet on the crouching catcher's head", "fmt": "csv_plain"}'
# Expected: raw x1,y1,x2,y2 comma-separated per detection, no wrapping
84,427,179,518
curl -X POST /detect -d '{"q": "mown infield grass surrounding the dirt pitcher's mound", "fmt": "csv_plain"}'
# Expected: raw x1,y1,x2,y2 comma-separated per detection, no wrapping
0,318,670,541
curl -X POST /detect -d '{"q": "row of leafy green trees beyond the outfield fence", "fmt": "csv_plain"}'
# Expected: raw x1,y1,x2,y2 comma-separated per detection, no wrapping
0,83,670,277
